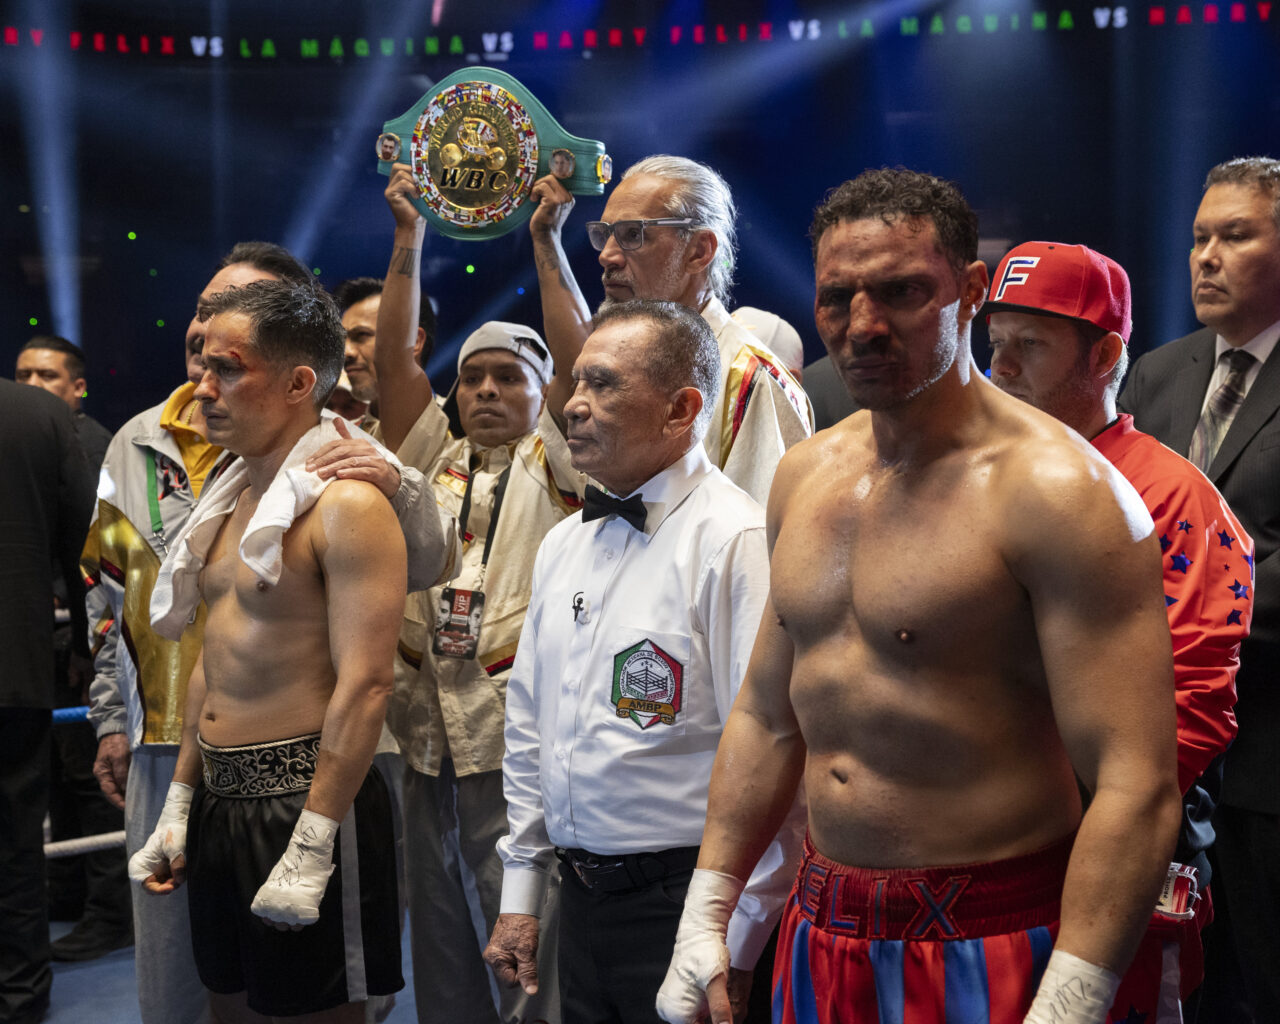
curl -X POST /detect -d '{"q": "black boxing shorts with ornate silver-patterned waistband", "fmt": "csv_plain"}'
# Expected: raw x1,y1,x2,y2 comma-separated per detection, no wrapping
187,733,402,1016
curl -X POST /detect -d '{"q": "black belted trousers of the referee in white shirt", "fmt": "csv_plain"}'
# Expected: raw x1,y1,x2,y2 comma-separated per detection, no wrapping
559,864,692,1024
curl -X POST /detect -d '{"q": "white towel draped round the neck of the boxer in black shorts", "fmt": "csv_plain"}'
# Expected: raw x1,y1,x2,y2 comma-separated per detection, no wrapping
151,410,401,640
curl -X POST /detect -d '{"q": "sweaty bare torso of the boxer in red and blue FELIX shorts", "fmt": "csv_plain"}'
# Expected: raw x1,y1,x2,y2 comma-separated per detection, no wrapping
772,413,1080,867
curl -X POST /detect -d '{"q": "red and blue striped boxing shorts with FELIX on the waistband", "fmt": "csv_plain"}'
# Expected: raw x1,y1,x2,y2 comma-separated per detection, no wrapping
773,836,1208,1024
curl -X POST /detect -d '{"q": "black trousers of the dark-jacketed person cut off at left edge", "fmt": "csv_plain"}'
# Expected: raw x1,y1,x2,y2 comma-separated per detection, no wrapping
0,708,54,1021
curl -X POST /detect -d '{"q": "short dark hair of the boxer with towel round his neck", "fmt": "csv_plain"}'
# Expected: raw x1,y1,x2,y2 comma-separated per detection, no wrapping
197,280,347,407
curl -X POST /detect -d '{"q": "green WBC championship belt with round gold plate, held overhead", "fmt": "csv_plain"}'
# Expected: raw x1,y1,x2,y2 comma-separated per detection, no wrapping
378,68,613,239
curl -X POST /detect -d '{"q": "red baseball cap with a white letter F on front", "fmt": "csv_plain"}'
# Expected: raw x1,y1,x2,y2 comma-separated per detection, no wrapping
986,242,1133,343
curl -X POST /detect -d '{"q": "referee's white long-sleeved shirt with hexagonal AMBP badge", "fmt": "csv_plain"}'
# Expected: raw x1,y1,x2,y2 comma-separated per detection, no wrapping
498,445,799,964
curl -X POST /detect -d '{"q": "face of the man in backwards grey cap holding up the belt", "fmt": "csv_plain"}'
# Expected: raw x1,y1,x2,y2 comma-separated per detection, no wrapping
456,348,543,448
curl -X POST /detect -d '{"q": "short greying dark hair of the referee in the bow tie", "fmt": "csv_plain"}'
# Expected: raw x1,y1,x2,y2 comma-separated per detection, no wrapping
591,298,721,440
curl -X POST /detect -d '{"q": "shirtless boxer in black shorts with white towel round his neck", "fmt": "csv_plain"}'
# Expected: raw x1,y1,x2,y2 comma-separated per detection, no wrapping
131,282,406,1021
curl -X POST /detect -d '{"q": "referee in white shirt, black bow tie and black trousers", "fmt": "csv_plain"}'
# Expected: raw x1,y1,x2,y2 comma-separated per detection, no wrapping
485,301,801,1024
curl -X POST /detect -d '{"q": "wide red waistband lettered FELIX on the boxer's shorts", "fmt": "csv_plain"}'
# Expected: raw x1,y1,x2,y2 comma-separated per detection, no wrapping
791,833,1075,940
